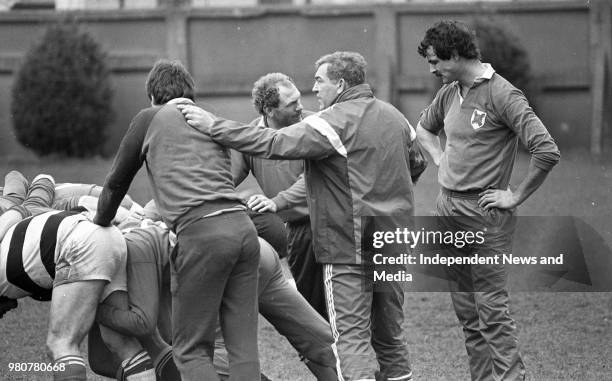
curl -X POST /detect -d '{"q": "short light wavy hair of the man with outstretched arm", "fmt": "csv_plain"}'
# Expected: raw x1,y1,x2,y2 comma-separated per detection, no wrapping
315,52,368,87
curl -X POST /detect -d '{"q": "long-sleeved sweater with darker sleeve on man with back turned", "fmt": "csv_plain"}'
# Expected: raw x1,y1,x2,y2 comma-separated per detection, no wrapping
98,98,243,233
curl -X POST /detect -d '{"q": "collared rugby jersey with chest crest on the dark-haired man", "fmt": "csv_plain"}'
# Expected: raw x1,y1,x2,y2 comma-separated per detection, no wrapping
420,64,560,191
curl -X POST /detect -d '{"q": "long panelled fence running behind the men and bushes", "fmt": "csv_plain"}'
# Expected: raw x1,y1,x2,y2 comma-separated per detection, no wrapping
0,0,612,155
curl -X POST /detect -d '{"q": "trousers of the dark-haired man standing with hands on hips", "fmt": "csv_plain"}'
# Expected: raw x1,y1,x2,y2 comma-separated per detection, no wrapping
437,191,525,381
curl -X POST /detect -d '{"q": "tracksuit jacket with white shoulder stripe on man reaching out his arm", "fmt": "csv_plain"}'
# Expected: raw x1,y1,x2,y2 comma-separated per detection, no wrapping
203,84,415,264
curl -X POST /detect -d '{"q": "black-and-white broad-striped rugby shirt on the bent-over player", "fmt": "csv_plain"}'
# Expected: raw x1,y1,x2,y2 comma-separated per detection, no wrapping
0,211,89,300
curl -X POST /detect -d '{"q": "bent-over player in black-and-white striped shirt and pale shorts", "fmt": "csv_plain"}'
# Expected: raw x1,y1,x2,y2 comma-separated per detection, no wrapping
0,174,155,380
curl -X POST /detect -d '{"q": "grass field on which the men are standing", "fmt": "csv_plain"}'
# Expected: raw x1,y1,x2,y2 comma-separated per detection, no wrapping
0,153,612,381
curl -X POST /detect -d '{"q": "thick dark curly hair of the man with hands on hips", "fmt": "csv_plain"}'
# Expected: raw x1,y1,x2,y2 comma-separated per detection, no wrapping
418,20,480,61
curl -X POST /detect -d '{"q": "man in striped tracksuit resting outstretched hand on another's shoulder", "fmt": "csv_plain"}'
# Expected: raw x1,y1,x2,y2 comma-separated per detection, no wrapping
180,52,424,380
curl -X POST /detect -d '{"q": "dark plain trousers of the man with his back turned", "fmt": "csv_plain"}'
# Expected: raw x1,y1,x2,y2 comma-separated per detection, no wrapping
170,212,259,381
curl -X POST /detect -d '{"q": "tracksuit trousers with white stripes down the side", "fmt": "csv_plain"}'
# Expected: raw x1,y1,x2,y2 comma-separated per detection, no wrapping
323,264,412,381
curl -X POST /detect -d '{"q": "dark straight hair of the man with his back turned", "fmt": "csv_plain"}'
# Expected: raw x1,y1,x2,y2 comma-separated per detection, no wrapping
146,59,195,105
